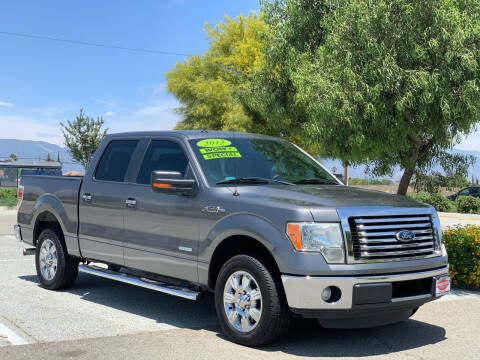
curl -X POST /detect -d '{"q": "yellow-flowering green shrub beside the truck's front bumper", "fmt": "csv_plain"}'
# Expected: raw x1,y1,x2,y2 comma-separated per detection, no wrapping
443,225,480,289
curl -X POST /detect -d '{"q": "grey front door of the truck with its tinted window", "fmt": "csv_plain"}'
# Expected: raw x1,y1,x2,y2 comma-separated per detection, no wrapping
124,138,201,282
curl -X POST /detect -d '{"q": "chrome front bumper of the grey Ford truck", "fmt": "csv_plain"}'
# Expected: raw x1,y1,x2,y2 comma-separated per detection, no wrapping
282,266,448,310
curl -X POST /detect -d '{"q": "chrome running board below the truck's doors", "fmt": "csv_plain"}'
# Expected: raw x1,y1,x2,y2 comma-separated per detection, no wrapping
78,265,200,300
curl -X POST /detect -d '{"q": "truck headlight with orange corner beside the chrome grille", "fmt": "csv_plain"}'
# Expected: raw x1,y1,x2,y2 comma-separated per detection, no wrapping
287,223,345,264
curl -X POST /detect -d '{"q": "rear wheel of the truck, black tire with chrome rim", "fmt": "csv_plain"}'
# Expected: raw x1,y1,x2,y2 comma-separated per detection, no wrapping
35,229,78,290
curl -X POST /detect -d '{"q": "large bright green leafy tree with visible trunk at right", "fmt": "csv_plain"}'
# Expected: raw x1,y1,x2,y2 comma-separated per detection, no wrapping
291,0,480,195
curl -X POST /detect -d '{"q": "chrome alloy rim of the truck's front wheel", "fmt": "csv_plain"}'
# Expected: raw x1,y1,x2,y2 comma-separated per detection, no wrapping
223,271,263,332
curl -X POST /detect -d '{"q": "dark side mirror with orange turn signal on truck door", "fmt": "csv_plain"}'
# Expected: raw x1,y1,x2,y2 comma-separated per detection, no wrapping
151,171,195,196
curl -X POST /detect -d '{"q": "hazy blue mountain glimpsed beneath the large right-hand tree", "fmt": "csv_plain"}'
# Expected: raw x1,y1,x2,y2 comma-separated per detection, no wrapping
320,149,480,182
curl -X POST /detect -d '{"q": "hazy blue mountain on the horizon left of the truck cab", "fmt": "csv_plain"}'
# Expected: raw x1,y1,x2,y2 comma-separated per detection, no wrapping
0,139,83,171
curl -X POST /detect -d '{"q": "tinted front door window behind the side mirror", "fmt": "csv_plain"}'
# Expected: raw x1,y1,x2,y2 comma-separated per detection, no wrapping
137,140,191,184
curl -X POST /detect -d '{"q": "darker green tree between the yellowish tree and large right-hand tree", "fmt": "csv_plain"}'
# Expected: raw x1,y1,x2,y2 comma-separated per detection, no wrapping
239,0,334,155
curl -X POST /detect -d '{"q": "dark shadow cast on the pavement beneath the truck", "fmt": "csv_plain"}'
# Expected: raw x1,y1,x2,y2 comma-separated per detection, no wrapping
20,273,445,357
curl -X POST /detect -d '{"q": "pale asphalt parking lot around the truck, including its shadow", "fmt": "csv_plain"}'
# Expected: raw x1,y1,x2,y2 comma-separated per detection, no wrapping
0,212,480,360
